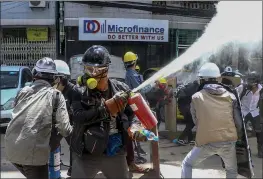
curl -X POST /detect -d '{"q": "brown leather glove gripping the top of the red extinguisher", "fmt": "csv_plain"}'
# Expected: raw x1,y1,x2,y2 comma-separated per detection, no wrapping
105,91,129,116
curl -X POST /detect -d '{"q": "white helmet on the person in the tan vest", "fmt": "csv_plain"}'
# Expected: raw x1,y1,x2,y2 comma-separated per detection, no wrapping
198,63,221,78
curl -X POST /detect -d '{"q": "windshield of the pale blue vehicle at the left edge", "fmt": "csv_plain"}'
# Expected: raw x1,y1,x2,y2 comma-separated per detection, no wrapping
0,71,19,89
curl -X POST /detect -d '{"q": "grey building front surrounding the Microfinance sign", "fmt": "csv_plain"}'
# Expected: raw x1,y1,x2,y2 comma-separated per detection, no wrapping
64,2,217,70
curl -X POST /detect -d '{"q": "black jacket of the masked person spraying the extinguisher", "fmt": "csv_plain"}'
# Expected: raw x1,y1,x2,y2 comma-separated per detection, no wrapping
71,79,134,156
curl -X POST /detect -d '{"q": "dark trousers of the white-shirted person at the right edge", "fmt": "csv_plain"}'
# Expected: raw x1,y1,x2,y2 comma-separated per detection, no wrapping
245,113,263,152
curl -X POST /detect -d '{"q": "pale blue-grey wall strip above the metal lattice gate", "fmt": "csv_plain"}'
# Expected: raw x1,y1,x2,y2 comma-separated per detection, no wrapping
0,1,55,26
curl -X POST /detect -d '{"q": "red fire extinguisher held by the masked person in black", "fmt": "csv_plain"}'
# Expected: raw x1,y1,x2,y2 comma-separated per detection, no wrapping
128,93,158,130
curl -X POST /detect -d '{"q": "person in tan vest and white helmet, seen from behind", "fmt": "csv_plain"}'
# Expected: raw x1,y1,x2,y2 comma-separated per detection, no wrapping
181,63,242,178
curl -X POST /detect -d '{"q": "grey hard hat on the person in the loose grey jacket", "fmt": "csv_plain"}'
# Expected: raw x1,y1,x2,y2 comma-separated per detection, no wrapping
32,57,58,79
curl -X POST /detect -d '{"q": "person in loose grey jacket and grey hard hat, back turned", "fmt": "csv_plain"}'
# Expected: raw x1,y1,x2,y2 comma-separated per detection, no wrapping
5,57,72,179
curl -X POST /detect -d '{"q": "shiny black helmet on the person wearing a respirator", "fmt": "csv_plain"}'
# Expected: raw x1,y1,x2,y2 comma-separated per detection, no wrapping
82,45,110,67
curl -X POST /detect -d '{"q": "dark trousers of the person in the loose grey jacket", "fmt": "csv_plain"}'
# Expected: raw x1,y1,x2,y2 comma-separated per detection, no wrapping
13,163,49,179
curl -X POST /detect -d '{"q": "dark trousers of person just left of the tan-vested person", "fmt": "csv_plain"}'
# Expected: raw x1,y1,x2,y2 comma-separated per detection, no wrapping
179,111,195,142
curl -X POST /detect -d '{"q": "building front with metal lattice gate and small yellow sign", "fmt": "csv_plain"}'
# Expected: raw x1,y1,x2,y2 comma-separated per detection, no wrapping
0,1,56,67
